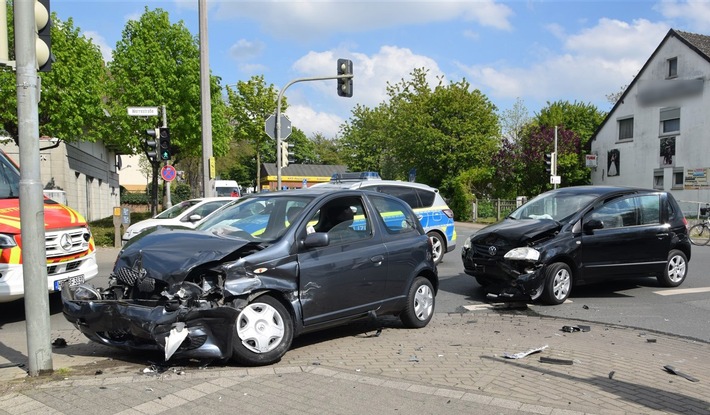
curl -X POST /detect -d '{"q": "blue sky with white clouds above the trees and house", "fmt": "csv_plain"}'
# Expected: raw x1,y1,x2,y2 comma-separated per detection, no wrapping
51,0,710,138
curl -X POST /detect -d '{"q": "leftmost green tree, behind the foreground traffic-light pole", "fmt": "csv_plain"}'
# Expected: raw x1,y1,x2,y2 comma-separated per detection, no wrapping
0,13,108,142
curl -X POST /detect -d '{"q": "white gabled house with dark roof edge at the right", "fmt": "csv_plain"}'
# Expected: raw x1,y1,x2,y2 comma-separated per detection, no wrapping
588,29,710,202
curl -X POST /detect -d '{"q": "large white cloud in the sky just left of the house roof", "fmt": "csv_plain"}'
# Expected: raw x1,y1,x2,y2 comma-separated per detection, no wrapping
459,19,669,110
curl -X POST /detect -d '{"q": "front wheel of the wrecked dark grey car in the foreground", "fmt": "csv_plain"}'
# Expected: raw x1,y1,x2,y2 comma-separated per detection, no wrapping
232,295,293,366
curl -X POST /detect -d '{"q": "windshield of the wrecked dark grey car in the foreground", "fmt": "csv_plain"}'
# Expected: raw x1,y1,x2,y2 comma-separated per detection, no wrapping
196,194,312,242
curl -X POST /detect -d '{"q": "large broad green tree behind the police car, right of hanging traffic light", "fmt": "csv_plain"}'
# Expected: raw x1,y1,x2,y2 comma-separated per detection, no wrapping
340,69,500,218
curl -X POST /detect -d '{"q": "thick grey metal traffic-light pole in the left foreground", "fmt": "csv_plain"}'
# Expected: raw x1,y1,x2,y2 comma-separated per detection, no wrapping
13,1,53,376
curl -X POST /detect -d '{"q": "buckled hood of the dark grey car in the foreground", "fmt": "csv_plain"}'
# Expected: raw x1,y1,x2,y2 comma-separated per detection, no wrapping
114,226,253,284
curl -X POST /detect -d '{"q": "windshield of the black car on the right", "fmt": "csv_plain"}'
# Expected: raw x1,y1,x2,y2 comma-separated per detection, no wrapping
508,192,597,222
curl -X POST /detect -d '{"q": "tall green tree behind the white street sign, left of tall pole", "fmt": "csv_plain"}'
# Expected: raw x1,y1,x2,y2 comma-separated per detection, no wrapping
107,7,230,179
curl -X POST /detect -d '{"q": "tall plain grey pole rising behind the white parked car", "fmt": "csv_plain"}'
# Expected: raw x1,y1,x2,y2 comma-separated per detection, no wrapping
198,0,214,197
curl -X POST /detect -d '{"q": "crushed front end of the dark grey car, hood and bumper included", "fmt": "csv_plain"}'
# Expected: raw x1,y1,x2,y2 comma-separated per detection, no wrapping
61,231,260,361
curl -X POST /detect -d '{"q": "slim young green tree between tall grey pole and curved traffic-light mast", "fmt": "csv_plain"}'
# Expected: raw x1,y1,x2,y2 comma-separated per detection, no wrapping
227,75,288,185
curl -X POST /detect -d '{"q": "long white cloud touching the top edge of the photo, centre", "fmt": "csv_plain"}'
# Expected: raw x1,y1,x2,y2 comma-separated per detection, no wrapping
214,0,513,40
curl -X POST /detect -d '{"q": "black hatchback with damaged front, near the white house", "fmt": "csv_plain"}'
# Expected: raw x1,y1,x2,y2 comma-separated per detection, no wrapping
461,186,690,305
